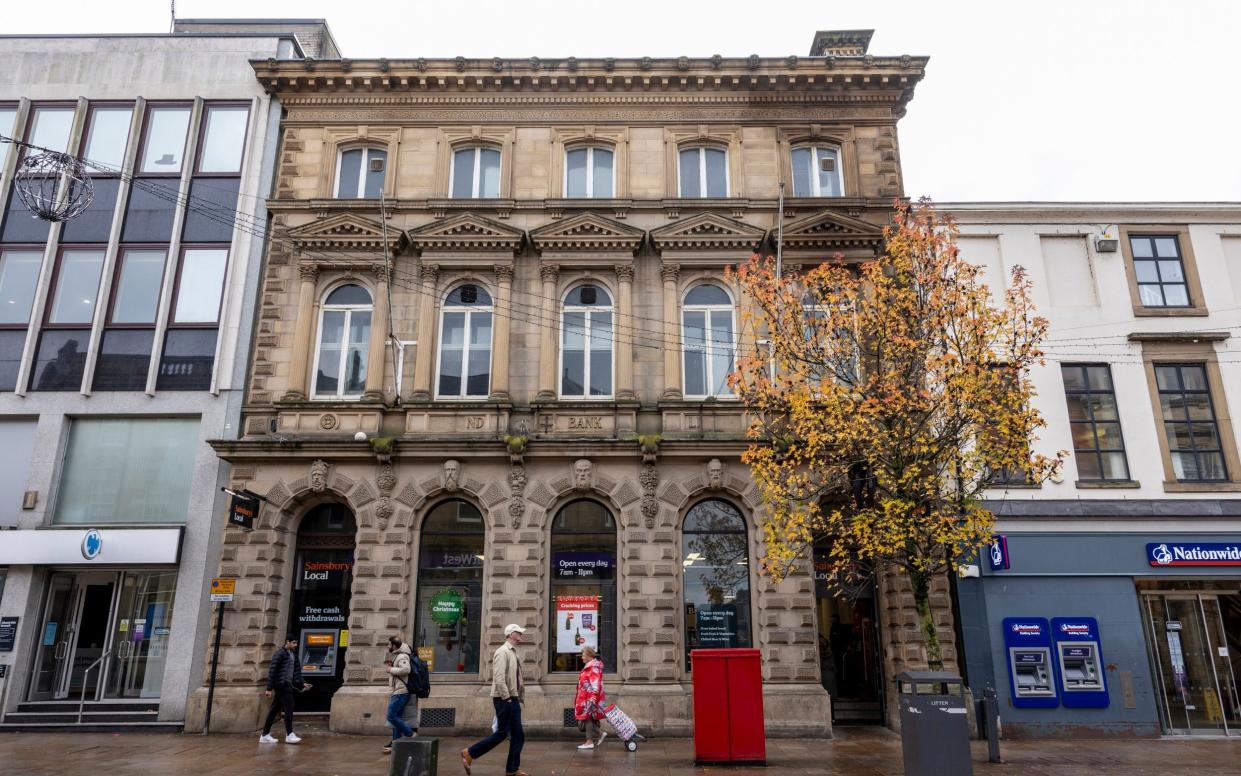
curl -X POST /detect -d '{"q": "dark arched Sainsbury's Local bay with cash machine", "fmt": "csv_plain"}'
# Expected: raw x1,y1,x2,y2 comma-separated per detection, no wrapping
286,504,357,711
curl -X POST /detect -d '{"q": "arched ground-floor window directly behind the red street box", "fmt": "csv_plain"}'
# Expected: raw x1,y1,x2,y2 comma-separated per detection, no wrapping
681,499,751,669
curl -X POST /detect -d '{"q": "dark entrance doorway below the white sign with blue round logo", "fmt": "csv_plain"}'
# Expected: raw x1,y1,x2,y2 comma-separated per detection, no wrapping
30,572,117,700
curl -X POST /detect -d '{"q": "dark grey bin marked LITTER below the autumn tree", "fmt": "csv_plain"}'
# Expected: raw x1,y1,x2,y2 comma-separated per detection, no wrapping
896,670,974,776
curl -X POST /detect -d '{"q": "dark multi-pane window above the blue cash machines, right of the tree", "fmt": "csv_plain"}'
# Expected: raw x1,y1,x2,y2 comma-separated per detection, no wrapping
1060,364,1129,480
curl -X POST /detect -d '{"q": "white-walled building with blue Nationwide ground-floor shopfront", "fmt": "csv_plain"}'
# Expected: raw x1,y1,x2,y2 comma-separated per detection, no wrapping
942,202,1241,736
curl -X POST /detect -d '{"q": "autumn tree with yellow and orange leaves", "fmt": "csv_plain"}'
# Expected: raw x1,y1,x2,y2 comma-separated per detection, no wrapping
731,201,1064,667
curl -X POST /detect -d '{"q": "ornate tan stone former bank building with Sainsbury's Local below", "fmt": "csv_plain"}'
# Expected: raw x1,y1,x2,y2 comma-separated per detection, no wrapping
187,31,938,735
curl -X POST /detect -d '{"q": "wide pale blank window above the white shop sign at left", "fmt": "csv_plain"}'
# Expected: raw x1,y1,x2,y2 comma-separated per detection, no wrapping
53,418,199,525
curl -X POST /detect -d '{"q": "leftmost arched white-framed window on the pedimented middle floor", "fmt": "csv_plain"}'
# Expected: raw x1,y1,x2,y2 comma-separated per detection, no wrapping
314,283,371,399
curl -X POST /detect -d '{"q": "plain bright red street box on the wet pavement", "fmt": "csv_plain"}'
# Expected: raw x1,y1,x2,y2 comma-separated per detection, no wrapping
690,649,767,765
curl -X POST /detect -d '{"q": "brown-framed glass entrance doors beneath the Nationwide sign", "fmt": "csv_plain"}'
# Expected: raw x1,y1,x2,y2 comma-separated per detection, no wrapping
1143,593,1241,735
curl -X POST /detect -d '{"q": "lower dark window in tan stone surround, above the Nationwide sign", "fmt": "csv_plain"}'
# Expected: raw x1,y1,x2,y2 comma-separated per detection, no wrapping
1154,364,1229,482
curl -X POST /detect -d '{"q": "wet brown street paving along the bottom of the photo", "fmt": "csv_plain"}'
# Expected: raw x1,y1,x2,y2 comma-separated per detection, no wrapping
0,728,1241,776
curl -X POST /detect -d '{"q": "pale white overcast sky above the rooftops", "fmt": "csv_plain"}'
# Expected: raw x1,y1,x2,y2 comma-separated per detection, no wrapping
9,0,1241,201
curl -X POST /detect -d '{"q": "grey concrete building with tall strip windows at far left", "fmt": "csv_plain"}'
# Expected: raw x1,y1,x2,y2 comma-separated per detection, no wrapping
0,20,335,726
